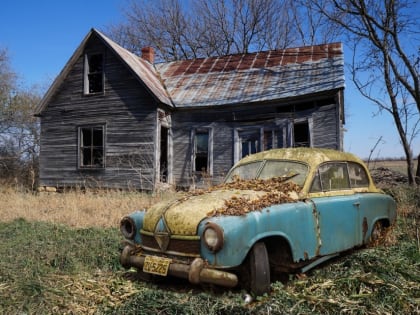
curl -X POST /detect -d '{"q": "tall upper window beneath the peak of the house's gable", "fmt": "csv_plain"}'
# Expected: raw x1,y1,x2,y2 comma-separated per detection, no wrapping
84,54,104,94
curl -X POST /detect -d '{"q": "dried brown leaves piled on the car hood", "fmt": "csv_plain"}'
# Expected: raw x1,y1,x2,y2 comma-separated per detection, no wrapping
207,177,301,217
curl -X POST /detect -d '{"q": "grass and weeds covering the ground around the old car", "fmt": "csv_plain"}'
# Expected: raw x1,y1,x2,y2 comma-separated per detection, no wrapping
0,187,420,315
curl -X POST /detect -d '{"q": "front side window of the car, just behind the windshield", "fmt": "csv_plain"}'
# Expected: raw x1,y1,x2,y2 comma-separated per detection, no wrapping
311,162,350,192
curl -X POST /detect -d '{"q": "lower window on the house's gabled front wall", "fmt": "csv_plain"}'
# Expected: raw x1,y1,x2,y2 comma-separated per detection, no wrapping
79,126,105,168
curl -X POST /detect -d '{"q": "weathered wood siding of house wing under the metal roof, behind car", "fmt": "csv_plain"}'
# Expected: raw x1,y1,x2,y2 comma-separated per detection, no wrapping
172,96,342,187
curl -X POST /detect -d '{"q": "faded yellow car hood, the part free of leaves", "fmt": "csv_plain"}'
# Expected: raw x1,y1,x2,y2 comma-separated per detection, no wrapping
143,190,267,235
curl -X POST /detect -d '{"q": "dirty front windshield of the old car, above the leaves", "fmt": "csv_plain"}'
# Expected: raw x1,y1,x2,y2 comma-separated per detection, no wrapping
225,160,308,186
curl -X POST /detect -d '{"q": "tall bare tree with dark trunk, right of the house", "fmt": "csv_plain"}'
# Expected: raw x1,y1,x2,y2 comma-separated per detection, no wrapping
312,0,420,184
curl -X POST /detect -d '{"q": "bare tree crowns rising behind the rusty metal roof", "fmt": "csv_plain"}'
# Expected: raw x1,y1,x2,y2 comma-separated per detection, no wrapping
109,0,337,61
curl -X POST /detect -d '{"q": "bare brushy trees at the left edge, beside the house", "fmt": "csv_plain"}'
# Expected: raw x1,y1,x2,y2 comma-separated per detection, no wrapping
0,50,40,189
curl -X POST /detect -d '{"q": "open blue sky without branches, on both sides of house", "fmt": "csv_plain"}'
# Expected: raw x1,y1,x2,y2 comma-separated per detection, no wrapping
0,0,420,158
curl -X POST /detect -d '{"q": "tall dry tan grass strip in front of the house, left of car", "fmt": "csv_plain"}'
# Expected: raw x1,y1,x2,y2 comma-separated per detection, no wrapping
0,188,173,228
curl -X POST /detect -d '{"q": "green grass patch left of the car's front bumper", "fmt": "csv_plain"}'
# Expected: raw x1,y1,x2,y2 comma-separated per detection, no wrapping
0,219,120,314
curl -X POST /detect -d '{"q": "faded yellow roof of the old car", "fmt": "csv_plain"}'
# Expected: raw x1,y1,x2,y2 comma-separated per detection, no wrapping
237,148,363,167
